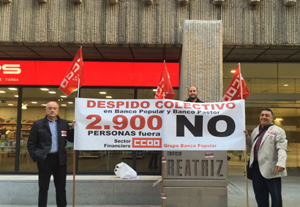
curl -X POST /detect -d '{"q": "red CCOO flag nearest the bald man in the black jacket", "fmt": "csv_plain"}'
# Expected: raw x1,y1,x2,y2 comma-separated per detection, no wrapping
59,47,84,96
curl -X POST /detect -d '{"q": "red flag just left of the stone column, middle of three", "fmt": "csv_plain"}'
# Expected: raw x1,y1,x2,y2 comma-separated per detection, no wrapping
155,61,175,99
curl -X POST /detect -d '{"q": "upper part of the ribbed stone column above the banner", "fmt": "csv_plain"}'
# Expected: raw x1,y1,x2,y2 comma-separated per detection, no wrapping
179,20,223,102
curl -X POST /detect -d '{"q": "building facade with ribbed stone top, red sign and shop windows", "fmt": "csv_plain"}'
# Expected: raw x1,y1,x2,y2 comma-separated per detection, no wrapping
0,0,300,174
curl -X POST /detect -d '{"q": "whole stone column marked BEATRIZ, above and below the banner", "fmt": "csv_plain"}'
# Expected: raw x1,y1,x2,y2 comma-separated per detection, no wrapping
162,20,228,207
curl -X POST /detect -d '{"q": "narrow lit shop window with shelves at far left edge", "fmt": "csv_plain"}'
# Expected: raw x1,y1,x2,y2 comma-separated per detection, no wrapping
0,87,18,171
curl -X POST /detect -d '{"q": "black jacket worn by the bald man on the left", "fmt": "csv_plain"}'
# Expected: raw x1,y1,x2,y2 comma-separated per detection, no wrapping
27,116,74,165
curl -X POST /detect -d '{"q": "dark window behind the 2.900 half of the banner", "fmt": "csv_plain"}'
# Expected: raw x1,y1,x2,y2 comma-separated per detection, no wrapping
78,88,136,173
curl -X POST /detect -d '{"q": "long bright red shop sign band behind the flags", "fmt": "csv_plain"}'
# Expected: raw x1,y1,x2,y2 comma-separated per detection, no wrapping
0,61,179,87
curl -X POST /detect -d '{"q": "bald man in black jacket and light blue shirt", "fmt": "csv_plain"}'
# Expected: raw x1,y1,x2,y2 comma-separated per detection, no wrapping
27,101,74,207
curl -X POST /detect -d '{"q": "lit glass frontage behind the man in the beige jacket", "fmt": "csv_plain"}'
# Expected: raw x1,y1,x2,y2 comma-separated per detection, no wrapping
223,63,300,175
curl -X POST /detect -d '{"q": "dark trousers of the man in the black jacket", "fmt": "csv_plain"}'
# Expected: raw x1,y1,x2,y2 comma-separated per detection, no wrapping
37,154,67,207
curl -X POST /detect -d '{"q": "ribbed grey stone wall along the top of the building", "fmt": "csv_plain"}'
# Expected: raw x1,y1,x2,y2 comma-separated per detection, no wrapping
0,0,300,45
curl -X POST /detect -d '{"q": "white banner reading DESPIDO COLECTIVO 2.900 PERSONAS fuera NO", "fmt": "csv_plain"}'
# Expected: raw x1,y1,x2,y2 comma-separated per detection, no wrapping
74,98,245,151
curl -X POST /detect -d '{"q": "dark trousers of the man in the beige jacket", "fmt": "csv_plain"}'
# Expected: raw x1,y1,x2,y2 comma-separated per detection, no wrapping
252,161,282,207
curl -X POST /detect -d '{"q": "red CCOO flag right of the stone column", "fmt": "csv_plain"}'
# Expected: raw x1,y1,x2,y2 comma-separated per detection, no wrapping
222,64,250,101
